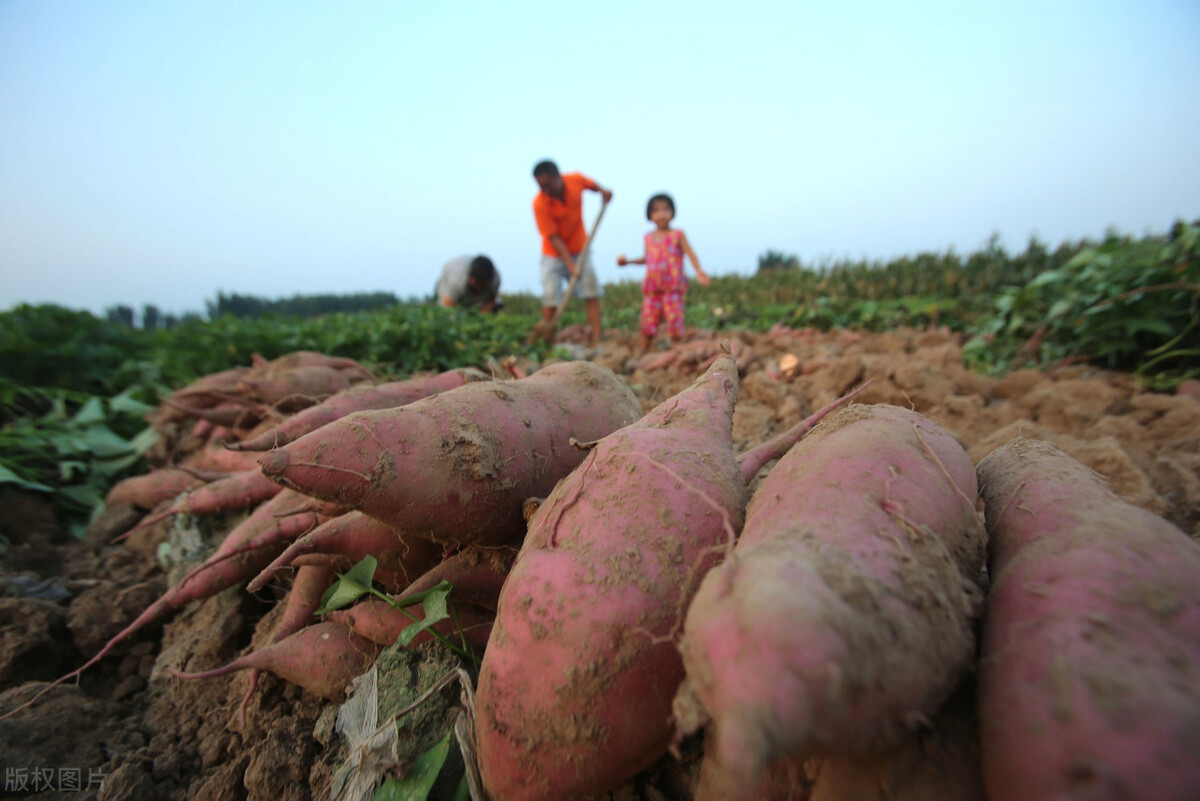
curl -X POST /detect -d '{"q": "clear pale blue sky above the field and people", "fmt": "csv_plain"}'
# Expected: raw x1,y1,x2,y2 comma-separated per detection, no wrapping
0,0,1200,314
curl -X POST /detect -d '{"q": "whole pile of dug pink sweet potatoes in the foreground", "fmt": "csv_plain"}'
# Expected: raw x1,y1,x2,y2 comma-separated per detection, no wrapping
11,353,1200,801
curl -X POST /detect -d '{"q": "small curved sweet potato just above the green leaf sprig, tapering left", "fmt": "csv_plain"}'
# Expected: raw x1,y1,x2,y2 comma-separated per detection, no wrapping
246,512,443,592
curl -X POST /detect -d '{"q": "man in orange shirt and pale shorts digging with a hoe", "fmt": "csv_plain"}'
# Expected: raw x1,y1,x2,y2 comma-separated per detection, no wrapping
533,161,612,344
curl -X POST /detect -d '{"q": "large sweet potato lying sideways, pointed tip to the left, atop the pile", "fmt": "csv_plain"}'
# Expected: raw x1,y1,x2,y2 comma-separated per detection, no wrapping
259,362,641,544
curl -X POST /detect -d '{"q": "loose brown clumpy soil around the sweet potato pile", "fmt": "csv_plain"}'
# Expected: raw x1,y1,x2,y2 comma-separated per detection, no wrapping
0,329,1200,801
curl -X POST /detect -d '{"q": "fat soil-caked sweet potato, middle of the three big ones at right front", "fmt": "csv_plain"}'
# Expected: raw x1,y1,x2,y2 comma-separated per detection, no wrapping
674,405,984,799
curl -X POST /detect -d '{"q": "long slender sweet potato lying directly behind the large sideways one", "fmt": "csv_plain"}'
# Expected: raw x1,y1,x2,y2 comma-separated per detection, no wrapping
229,367,487,451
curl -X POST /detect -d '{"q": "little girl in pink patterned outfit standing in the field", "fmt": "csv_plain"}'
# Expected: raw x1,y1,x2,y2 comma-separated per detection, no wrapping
617,194,708,351
